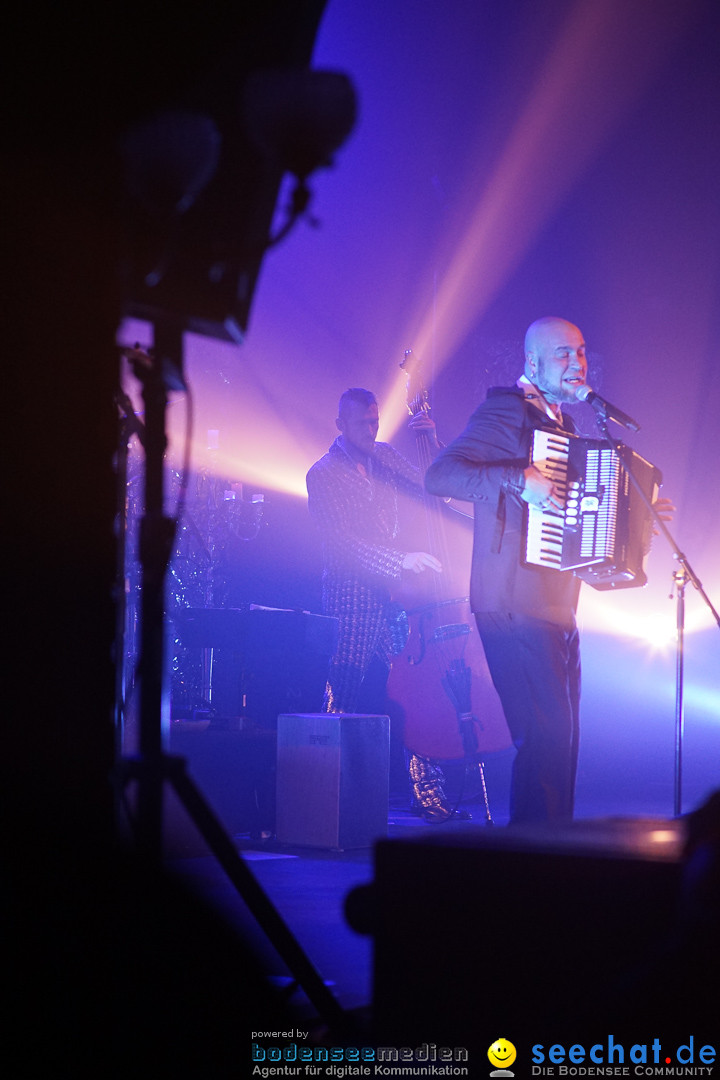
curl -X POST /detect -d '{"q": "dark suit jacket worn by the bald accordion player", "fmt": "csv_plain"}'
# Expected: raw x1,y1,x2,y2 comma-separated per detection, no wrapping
425,387,580,626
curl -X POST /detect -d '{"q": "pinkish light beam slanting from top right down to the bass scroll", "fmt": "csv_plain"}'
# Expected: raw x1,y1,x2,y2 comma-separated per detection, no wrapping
382,0,692,433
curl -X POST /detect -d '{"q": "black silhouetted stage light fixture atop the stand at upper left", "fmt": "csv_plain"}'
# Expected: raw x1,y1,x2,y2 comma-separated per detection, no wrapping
120,12,356,343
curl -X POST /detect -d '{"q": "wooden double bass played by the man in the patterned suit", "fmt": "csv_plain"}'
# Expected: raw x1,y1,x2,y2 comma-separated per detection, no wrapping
389,350,512,794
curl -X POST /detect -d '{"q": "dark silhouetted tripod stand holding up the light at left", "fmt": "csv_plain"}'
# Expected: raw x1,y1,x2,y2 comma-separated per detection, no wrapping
116,320,354,1037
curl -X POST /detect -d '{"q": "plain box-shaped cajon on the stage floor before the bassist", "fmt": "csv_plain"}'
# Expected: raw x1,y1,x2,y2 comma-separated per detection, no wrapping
275,713,390,851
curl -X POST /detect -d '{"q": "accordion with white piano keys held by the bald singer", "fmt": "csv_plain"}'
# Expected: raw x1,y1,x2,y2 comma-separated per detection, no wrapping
524,430,662,589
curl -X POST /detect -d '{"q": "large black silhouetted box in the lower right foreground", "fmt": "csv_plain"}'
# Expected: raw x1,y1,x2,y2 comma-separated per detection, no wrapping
355,820,686,1045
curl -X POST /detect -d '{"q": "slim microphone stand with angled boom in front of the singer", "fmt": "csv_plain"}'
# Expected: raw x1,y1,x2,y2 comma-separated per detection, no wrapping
593,412,720,818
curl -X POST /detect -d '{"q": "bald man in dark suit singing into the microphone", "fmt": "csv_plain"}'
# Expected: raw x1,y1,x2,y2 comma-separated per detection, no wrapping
425,316,587,823
